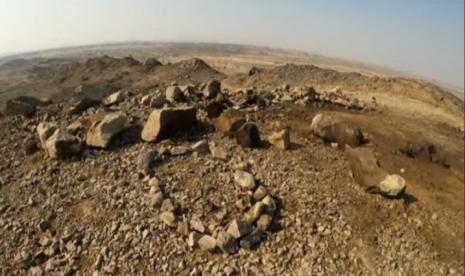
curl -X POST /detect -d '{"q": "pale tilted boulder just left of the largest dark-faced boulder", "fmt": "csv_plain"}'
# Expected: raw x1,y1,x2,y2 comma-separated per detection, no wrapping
86,112,127,148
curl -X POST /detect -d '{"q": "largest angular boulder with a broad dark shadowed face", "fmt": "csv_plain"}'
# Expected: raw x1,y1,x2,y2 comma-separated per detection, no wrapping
141,107,197,142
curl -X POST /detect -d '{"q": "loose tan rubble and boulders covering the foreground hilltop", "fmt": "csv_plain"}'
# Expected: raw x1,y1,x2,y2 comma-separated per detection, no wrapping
0,70,463,275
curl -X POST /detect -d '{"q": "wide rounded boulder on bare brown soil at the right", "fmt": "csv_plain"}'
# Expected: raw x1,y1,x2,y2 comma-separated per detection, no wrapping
310,114,364,147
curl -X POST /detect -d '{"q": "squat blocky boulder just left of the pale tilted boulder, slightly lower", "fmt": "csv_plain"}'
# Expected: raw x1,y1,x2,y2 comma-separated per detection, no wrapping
45,128,82,159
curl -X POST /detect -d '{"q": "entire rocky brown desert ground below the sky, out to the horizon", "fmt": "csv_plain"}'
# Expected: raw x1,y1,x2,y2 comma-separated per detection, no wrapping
0,42,465,275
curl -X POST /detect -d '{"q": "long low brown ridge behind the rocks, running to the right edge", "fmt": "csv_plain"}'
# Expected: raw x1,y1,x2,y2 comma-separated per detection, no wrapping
225,64,464,114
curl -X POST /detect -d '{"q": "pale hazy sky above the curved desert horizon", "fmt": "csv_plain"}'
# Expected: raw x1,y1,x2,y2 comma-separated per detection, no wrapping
0,0,464,88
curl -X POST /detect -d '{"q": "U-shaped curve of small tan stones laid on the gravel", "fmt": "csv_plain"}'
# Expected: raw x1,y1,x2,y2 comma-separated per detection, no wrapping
149,167,279,254
